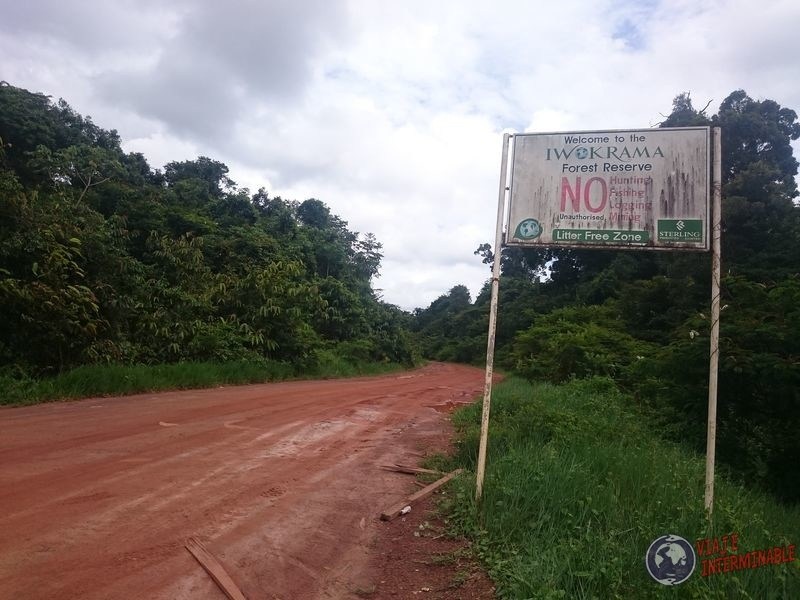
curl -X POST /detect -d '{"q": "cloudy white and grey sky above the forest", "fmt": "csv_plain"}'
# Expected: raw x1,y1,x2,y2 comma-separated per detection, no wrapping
0,0,800,309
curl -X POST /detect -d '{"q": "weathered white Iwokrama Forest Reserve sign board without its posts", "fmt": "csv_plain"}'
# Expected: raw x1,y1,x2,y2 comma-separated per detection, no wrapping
506,127,711,250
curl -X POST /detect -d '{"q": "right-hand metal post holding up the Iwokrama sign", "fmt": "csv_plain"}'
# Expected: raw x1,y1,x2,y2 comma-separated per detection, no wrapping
705,127,722,518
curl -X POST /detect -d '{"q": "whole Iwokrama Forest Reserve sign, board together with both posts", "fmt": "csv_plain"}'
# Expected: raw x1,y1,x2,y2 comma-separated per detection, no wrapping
475,127,722,519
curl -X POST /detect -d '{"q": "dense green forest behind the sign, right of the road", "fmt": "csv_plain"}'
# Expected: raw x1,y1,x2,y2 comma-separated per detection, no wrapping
412,90,800,501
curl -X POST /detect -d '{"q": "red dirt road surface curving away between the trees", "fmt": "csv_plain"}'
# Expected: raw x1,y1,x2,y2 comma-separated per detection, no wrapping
0,364,483,600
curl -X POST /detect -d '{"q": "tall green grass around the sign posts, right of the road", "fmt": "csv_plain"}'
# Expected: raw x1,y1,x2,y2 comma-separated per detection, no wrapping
442,378,800,600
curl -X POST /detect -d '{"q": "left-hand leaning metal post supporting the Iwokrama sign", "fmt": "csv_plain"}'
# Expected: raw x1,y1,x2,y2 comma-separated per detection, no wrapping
475,133,511,501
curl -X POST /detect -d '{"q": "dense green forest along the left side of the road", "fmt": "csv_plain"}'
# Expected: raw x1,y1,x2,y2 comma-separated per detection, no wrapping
0,82,412,377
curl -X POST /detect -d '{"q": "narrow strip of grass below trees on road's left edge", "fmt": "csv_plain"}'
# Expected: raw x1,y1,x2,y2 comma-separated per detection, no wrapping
0,357,407,406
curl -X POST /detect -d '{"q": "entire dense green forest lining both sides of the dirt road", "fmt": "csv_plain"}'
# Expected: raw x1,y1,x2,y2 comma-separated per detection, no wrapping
0,82,800,502
